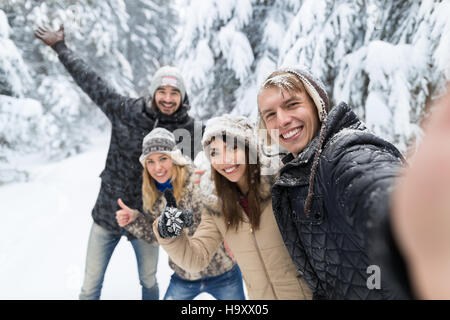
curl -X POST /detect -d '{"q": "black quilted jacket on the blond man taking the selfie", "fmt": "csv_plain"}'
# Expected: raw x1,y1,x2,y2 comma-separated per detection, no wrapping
272,103,403,300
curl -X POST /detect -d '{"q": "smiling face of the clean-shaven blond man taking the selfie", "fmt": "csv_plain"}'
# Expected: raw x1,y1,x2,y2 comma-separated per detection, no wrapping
258,87,320,156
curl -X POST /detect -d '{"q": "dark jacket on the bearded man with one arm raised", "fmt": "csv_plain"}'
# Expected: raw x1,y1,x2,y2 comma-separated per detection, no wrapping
53,41,203,238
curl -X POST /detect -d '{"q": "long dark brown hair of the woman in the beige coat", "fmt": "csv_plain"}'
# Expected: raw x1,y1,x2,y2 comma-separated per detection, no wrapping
210,137,261,230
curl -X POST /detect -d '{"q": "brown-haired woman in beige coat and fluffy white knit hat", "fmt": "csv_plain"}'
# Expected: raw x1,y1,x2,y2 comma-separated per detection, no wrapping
153,115,311,299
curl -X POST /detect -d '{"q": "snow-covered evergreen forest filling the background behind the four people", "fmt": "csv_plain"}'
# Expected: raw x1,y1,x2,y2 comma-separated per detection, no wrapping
0,0,450,184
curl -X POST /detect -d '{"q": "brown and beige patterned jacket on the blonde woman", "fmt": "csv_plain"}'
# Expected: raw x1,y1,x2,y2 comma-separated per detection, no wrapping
125,167,236,280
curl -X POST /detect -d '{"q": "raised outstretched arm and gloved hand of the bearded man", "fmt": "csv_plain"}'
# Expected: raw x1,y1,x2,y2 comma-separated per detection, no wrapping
34,25,127,118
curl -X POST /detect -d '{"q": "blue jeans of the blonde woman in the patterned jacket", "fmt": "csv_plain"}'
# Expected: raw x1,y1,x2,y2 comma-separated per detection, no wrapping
164,265,245,300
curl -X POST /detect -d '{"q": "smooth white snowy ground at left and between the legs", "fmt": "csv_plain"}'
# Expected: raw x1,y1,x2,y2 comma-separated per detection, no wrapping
0,132,212,300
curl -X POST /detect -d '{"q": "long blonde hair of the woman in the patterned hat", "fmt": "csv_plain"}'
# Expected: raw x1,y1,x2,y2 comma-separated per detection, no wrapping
142,163,187,212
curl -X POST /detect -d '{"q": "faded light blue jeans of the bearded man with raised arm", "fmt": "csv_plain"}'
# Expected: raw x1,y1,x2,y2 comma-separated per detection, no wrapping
79,222,159,300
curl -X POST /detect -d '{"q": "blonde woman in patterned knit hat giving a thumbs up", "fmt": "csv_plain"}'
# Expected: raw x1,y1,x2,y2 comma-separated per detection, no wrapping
116,128,245,300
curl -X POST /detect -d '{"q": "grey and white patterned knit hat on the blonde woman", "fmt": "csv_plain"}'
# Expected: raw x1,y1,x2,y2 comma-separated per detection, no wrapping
139,128,190,168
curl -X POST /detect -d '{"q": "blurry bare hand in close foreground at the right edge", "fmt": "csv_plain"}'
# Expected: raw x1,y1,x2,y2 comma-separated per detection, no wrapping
392,87,450,299
